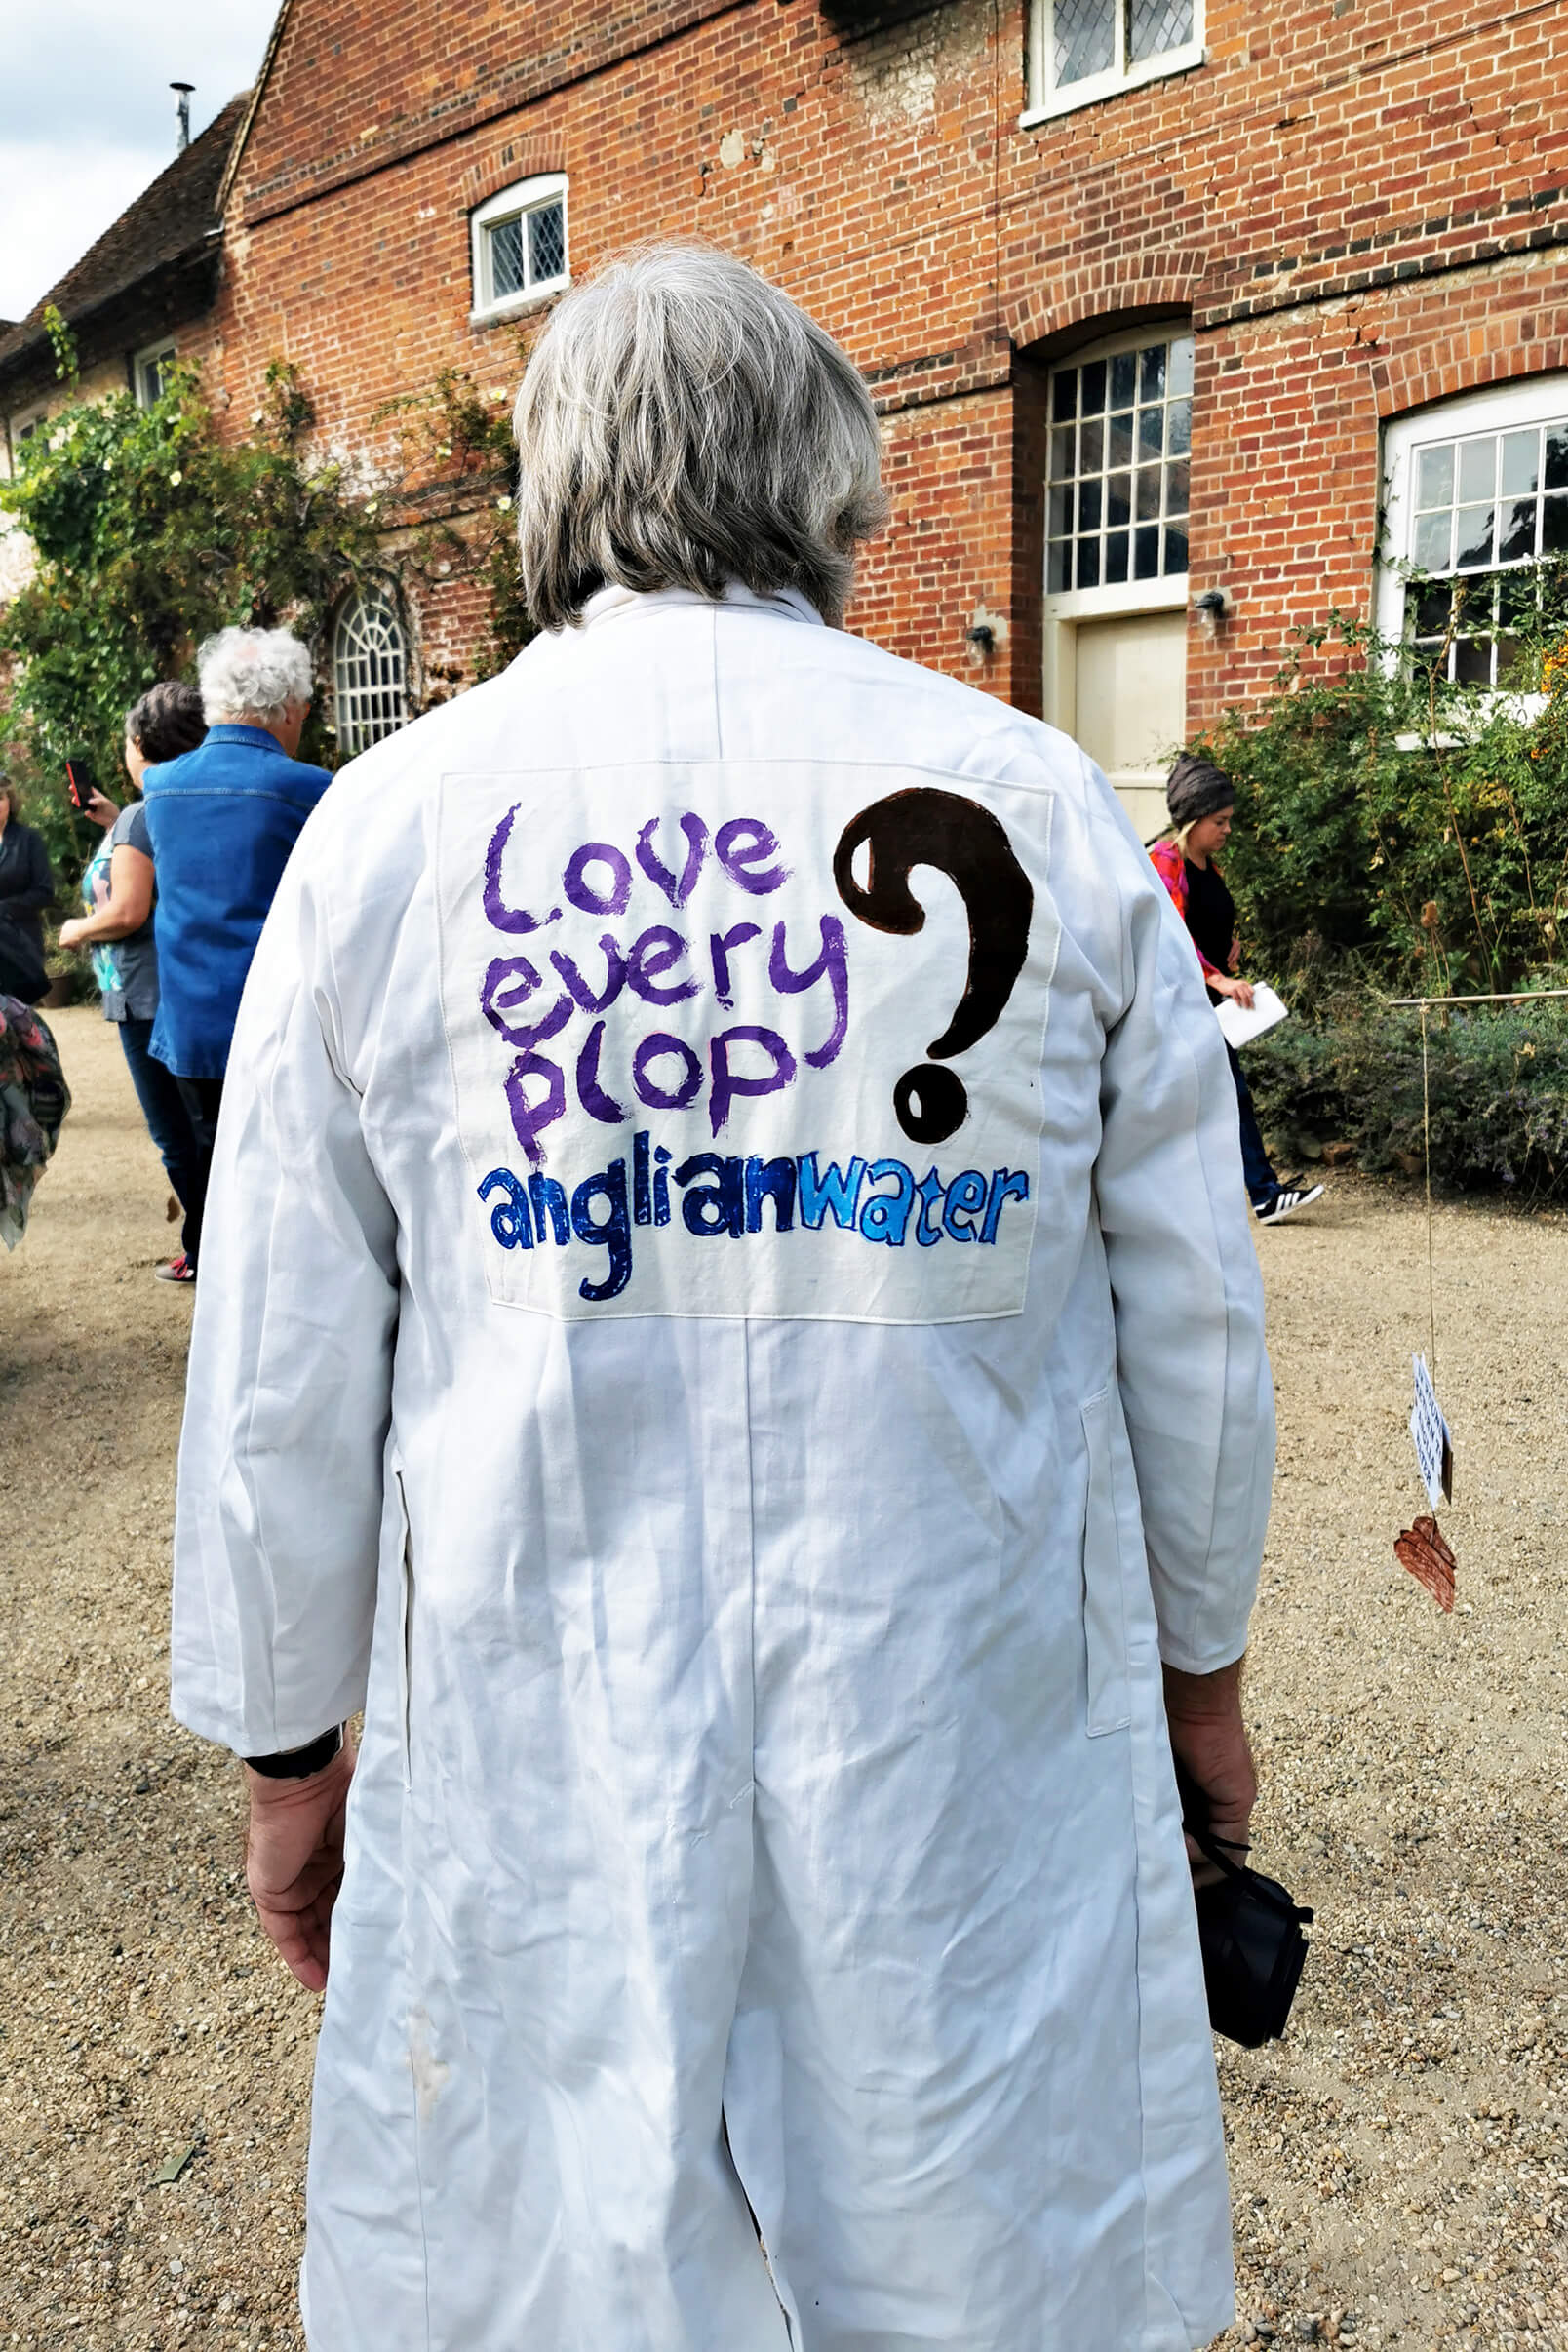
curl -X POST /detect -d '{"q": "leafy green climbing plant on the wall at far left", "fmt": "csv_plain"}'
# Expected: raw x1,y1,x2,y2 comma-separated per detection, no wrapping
0,352,383,851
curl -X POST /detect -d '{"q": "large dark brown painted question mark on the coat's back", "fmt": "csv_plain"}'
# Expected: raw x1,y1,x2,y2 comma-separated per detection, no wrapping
832,786,1035,1143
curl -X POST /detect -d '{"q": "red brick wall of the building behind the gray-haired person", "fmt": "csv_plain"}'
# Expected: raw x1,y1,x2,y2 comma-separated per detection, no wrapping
214,0,1568,722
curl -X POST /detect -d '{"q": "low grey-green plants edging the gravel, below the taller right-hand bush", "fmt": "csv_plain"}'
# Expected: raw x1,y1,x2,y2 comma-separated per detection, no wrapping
1246,993,1568,1199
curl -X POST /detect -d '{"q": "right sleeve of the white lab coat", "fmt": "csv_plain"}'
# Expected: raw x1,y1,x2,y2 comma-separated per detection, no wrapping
1088,769,1274,1674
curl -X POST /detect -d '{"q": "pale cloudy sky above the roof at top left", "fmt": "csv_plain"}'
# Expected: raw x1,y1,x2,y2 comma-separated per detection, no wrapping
0,0,277,318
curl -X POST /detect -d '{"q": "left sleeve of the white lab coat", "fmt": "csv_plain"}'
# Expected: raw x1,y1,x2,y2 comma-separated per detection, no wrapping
172,844,397,1754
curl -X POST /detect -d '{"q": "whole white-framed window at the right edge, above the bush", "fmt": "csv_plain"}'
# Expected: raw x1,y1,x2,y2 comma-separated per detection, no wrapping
1378,374,1568,689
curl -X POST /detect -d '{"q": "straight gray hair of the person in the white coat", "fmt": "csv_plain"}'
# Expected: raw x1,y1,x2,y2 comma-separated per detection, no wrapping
515,245,886,628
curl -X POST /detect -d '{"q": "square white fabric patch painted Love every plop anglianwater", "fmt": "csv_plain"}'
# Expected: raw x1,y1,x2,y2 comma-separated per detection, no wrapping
437,762,1060,1322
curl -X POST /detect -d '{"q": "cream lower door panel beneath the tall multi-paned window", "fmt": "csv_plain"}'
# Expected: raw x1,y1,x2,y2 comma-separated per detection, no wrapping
1072,611,1187,842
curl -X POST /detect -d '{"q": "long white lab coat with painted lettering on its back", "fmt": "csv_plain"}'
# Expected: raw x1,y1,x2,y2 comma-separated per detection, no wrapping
174,590,1272,2352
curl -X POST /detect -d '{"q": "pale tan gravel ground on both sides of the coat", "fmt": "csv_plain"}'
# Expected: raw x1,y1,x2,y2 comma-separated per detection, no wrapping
0,1011,1568,2352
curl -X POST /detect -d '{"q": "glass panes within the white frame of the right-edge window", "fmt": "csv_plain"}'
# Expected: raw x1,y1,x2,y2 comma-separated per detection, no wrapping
1403,413,1568,686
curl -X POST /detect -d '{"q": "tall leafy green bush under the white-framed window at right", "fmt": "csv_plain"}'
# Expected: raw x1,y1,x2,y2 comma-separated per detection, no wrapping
1195,576,1568,995
